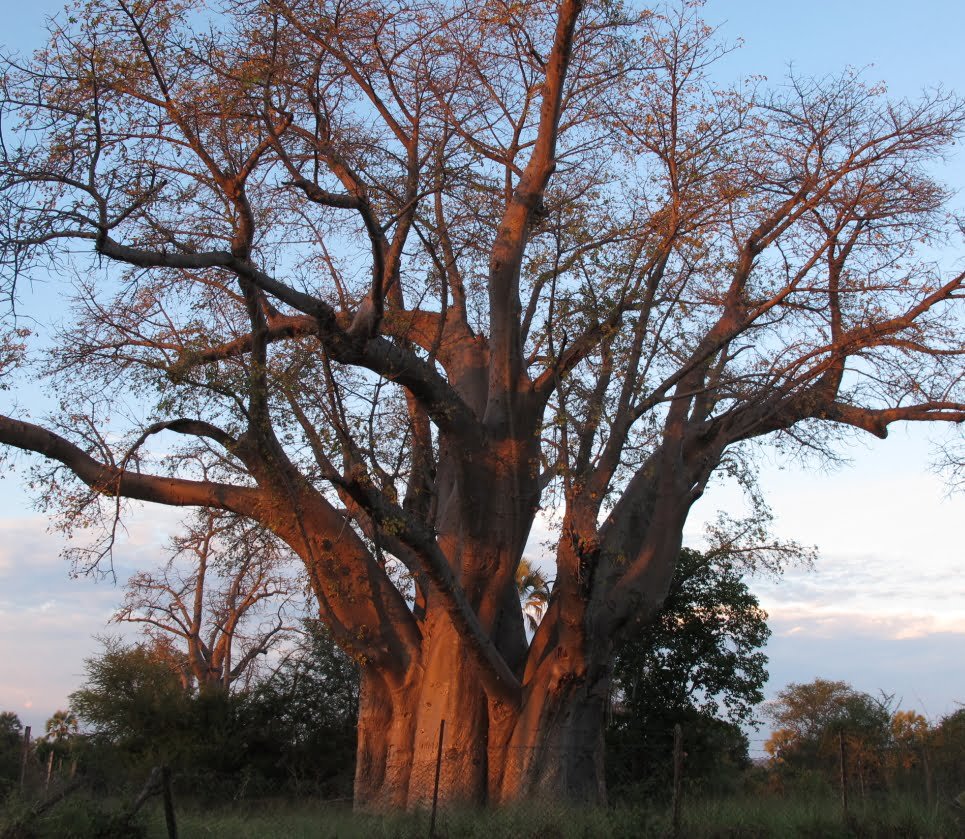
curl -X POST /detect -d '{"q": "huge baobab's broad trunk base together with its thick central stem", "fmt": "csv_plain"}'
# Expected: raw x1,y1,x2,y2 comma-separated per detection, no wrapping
332,404,632,810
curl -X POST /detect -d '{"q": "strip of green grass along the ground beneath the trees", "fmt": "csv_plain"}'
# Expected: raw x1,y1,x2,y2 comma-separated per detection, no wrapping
0,795,965,839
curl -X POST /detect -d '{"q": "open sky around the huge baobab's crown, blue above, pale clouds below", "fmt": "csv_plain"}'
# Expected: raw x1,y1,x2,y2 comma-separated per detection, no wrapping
0,0,965,740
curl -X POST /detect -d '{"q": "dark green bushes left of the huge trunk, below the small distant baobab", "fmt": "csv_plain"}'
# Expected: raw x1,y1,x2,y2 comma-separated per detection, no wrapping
65,622,358,799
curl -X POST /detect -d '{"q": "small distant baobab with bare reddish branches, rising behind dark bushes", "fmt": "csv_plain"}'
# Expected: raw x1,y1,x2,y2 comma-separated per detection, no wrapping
113,508,298,692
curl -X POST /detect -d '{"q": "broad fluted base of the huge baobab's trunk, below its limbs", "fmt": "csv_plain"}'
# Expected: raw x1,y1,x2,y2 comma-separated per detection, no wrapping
355,618,608,810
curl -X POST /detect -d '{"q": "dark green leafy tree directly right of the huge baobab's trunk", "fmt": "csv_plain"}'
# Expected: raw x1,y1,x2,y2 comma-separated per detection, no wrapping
608,548,770,792
